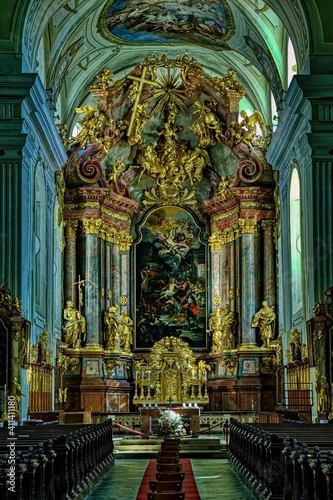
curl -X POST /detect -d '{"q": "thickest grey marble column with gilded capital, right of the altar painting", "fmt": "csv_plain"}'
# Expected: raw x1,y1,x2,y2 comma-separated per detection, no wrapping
239,219,260,344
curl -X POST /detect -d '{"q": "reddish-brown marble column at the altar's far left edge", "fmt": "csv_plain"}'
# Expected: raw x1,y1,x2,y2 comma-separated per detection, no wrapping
64,220,78,307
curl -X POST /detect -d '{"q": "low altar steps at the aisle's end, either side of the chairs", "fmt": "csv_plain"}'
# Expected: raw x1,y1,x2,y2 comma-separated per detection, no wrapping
114,437,227,459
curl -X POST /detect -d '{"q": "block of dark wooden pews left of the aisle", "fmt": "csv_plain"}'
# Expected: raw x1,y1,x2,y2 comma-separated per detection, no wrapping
0,421,114,500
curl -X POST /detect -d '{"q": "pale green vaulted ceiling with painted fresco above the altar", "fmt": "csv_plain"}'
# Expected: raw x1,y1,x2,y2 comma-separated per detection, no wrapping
0,0,333,135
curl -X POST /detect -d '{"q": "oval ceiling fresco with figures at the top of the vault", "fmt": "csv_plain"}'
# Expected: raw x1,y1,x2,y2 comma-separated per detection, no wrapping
100,0,235,50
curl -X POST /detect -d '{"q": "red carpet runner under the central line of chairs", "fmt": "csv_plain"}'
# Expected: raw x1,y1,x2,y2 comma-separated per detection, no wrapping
136,458,200,500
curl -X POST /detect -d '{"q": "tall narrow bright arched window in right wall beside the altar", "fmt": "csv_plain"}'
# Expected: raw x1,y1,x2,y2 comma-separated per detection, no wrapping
290,168,302,314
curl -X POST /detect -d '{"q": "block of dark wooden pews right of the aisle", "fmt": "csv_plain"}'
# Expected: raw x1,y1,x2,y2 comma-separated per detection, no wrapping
228,419,333,500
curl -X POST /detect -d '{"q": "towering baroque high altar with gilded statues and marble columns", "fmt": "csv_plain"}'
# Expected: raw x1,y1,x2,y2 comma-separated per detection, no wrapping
57,53,281,412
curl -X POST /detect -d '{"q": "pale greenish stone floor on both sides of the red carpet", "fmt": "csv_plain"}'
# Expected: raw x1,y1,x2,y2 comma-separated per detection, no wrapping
86,458,256,500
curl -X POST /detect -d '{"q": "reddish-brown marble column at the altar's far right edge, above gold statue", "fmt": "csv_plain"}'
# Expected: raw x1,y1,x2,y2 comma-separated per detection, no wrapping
261,219,276,306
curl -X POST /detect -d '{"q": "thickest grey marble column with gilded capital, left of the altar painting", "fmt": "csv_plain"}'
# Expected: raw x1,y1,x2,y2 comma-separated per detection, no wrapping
82,219,101,347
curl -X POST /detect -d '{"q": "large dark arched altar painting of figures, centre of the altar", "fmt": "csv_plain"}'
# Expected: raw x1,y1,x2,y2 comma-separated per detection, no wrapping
135,206,207,350
